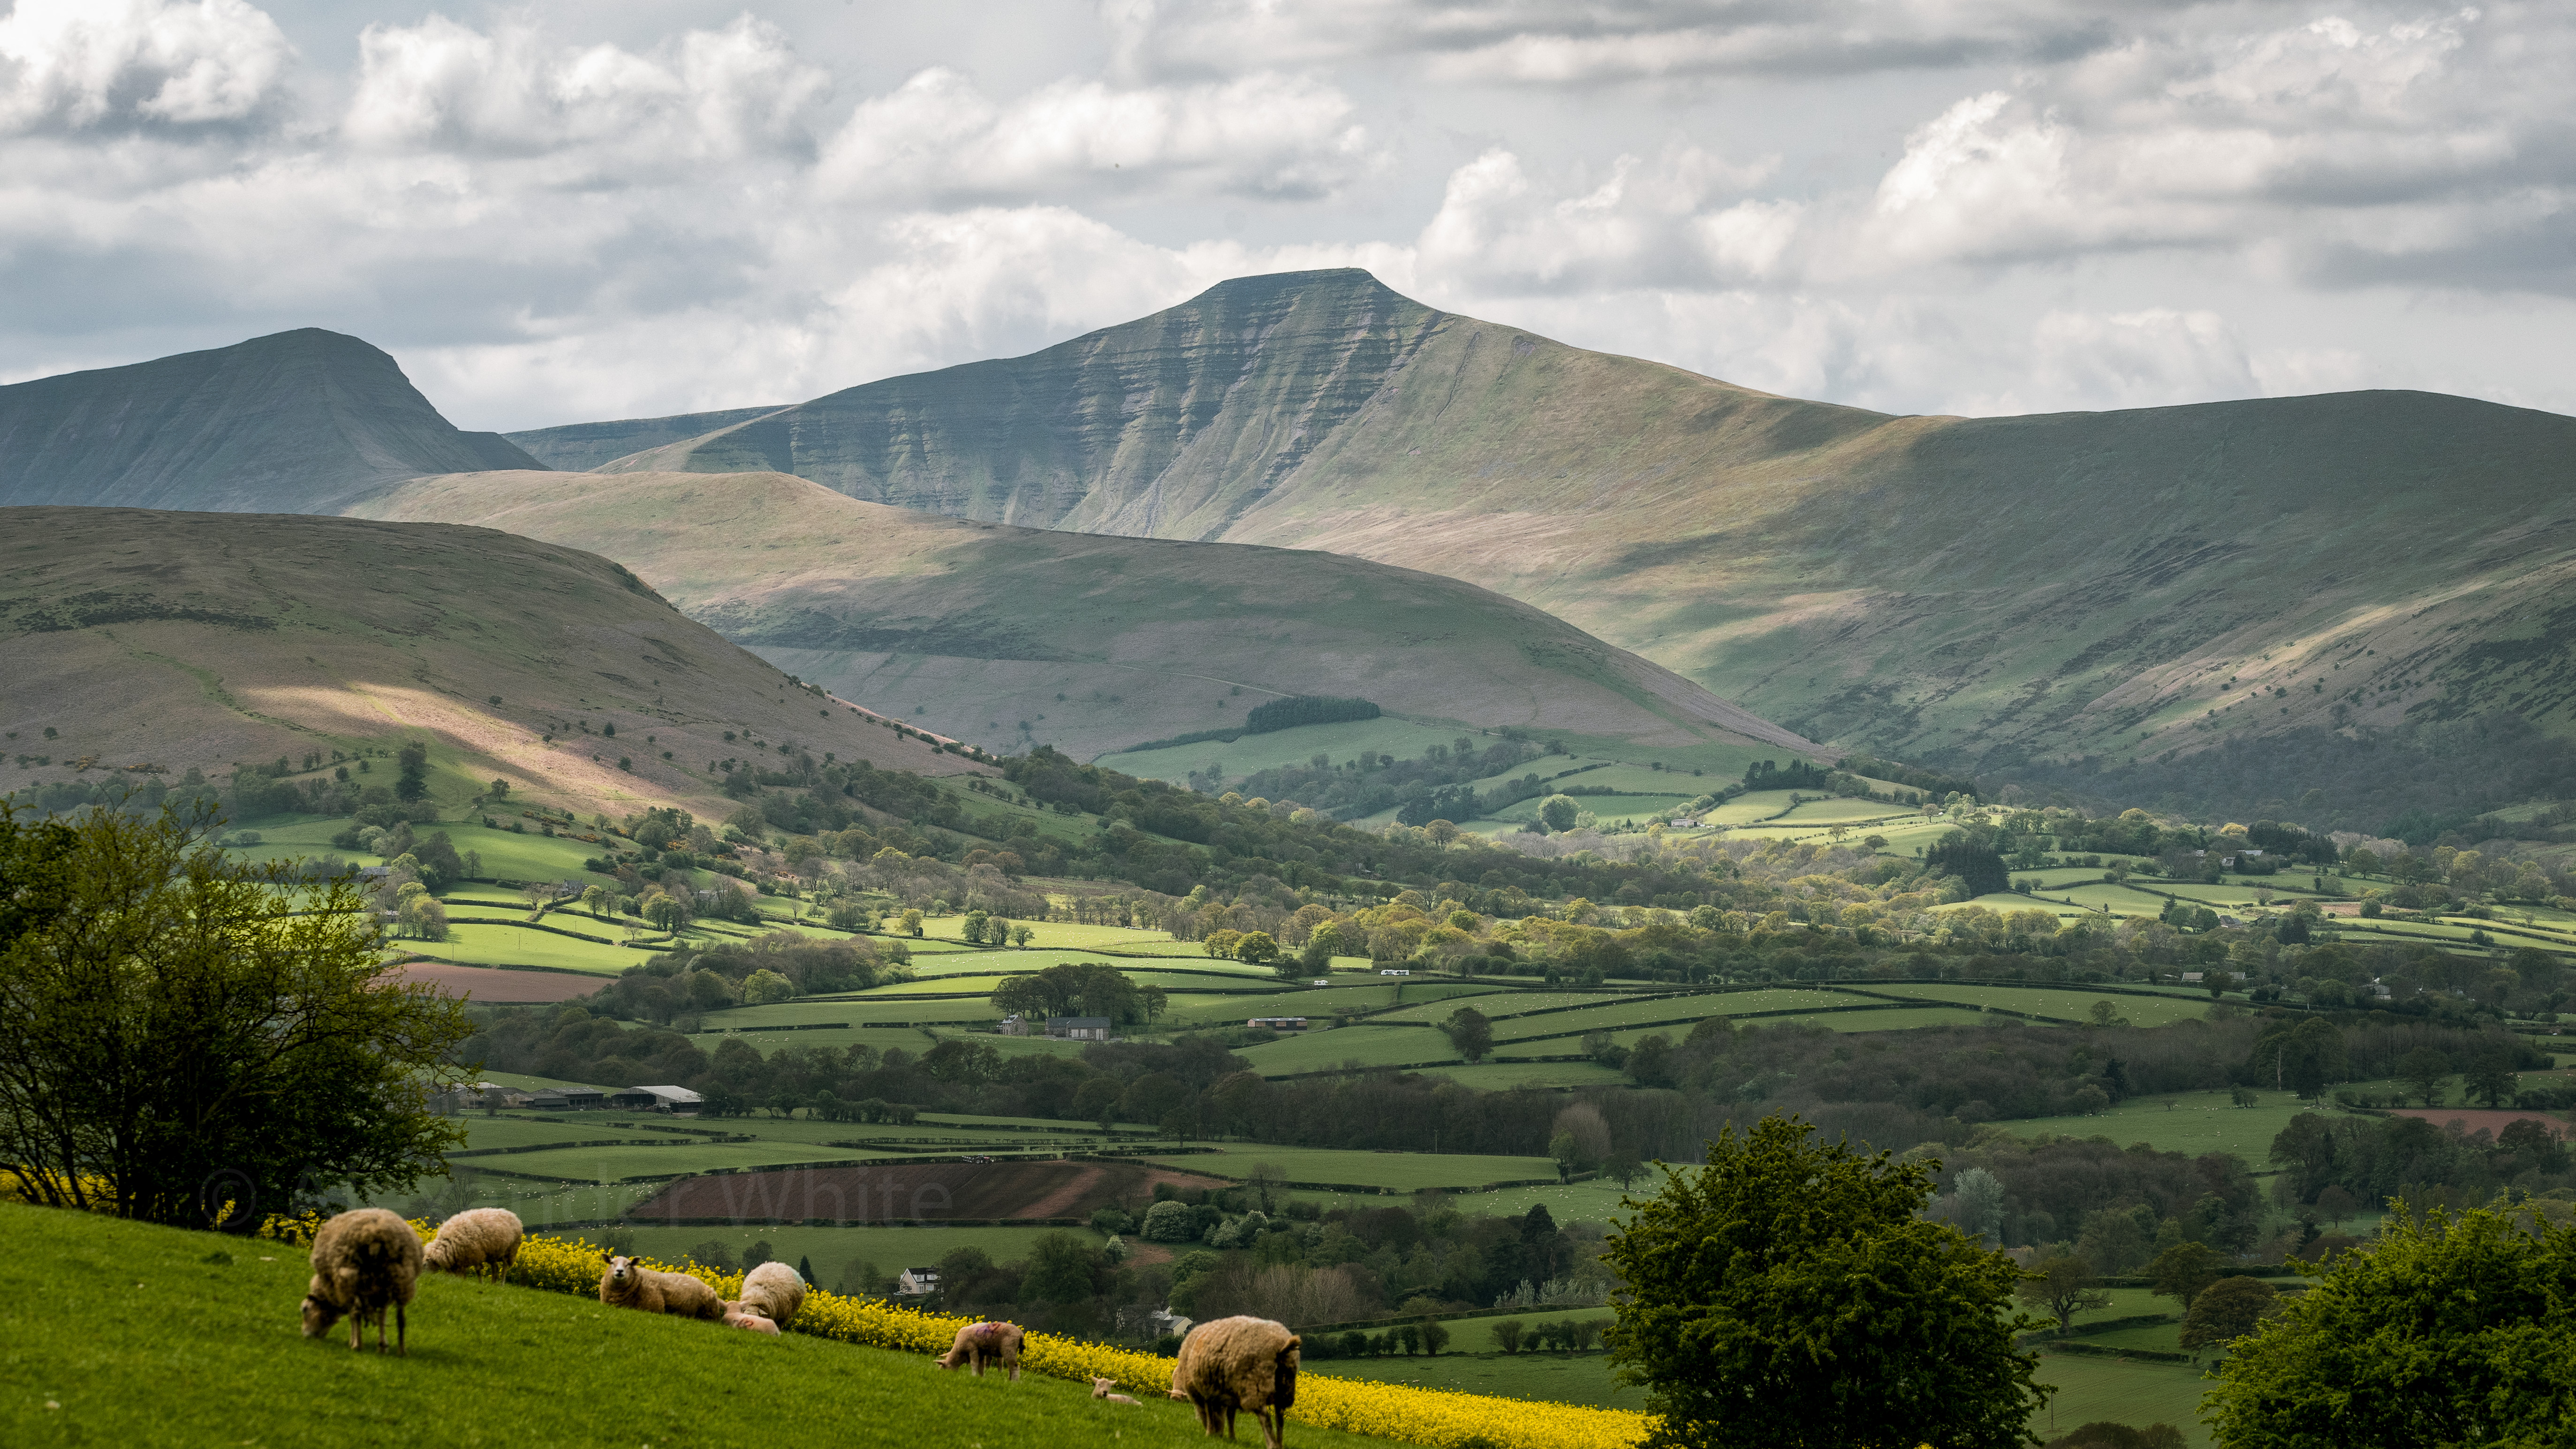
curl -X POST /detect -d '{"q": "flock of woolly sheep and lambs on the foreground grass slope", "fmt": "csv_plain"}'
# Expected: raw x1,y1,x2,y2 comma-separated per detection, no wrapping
304,1206,1298,1449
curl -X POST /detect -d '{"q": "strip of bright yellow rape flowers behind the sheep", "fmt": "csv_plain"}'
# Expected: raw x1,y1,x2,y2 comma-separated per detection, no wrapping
263,1217,1654,1449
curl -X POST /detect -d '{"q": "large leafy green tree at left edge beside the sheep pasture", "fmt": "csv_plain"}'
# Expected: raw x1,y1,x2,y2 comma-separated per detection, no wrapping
0,802,474,1230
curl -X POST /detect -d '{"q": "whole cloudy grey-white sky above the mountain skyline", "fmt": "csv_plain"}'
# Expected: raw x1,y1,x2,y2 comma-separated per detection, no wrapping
0,0,2576,431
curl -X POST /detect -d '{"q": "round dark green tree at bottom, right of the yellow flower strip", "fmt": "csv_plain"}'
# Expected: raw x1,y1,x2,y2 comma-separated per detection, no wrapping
1605,1116,2051,1449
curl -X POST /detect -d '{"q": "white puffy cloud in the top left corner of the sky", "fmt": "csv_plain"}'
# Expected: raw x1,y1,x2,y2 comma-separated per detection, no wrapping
0,0,294,134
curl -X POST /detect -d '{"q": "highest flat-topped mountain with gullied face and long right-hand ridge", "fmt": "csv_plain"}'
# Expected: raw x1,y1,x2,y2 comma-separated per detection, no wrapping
603,271,2576,766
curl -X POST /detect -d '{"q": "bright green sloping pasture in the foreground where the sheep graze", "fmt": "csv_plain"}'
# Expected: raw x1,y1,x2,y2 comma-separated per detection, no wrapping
0,1204,1386,1449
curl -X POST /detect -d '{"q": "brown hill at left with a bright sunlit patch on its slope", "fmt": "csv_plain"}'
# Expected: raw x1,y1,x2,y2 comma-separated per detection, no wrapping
0,508,969,820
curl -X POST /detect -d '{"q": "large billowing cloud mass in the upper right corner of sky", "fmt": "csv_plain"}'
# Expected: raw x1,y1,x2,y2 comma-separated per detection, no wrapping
1855,8,2576,289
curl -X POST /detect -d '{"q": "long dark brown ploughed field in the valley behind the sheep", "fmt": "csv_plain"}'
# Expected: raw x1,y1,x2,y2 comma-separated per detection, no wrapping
626,1163,1231,1222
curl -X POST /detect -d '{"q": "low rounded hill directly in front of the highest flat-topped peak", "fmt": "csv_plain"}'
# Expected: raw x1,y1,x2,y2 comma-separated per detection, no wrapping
353,472,1811,771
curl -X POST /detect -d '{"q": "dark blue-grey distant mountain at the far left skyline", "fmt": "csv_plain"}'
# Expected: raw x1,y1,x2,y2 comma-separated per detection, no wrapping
0,327,544,513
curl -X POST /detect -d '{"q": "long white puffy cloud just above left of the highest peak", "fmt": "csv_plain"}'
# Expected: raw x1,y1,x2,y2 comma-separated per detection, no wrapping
822,67,1373,198
